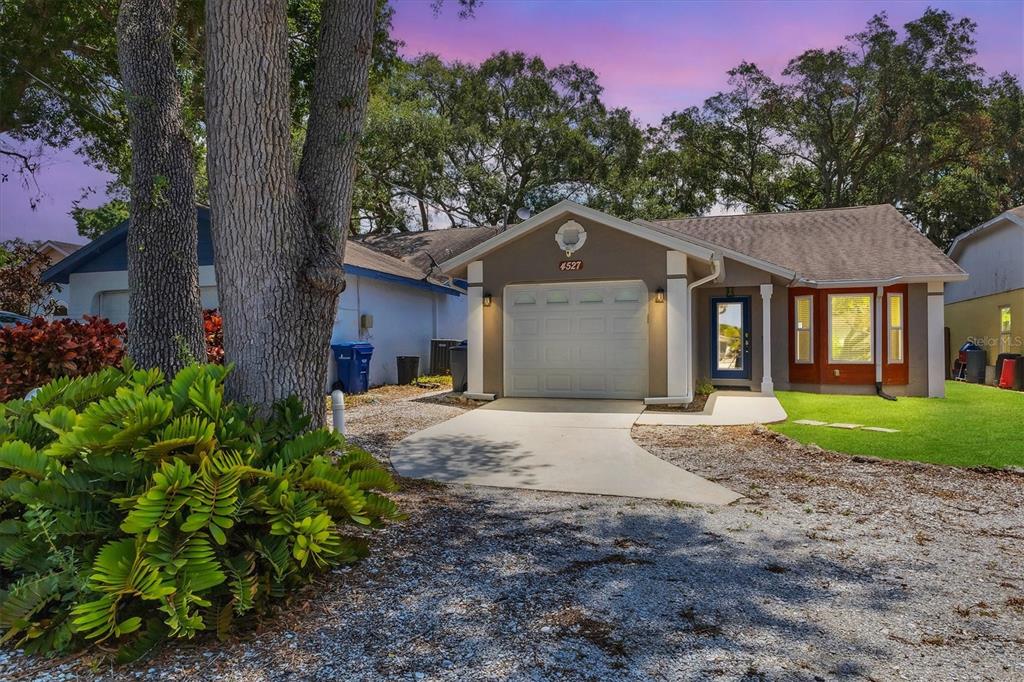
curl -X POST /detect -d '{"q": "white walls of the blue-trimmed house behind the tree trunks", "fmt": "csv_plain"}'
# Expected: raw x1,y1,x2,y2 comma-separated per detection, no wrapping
71,265,466,387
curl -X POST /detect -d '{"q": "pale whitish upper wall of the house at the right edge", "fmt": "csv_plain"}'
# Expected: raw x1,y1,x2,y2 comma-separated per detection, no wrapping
945,220,1024,303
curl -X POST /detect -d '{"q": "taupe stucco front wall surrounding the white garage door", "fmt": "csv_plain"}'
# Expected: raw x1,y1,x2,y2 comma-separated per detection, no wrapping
482,216,667,396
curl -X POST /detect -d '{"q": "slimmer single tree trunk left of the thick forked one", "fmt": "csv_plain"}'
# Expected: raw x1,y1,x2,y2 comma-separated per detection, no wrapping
117,0,206,376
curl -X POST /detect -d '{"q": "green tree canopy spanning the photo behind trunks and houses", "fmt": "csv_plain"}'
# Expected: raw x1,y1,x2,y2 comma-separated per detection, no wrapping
0,0,1024,246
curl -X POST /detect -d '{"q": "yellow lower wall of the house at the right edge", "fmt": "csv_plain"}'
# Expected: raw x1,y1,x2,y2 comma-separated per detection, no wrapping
946,289,1024,365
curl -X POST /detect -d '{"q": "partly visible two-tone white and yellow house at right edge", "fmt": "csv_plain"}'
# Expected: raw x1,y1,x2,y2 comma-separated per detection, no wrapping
945,206,1024,383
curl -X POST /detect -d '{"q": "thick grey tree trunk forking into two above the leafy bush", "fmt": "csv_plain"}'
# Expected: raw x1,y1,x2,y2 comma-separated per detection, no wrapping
206,0,375,418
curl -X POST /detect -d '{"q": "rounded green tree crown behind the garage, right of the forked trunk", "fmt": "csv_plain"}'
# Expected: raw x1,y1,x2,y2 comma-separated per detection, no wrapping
353,52,642,231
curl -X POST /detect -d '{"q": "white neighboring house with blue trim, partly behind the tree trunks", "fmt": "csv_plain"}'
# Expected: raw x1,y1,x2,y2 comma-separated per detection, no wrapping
44,207,466,384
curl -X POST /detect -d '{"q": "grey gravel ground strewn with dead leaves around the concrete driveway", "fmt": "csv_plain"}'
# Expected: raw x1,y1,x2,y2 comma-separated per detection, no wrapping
0,391,1024,681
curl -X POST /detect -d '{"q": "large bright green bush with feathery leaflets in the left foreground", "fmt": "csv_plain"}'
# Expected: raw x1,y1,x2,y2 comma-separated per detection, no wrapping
0,363,400,662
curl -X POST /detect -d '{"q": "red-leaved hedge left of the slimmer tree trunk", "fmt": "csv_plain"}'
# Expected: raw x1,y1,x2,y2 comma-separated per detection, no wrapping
0,315,125,401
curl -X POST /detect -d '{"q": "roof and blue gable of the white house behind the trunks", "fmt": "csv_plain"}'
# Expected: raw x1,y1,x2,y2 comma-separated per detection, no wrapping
42,206,463,294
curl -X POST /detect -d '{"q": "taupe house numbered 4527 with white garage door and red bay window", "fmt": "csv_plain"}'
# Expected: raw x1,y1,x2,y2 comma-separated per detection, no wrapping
440,201,967,403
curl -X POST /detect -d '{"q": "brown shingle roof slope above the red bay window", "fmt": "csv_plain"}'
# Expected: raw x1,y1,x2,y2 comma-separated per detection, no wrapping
653,204,964,282
